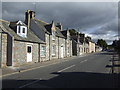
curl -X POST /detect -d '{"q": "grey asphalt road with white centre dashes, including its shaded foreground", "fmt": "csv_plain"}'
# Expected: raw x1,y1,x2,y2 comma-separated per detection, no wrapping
2,52,118,90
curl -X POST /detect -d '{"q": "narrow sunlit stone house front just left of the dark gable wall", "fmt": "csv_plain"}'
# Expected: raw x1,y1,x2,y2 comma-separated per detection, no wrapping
61,29,72,57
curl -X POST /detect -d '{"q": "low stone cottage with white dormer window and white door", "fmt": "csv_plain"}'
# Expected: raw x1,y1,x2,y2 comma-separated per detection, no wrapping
0,20,45,67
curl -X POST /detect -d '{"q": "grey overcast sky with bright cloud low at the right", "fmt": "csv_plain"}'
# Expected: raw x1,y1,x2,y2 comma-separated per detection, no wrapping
2,2,118,44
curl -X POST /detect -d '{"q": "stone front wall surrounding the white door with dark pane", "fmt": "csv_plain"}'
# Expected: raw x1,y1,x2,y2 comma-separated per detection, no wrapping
13,41,39,66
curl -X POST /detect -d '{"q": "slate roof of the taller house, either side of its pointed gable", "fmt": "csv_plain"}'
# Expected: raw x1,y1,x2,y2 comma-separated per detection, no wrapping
31,18,65,38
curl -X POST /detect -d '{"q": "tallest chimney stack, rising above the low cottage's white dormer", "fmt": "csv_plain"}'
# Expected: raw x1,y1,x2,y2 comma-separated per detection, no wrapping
25,10,35,29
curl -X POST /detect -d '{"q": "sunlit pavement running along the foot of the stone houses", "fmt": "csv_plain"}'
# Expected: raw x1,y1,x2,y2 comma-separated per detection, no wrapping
0,54,86,77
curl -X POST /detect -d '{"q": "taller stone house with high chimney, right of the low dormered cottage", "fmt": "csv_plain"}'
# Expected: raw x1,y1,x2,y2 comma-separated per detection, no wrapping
25,10,65,62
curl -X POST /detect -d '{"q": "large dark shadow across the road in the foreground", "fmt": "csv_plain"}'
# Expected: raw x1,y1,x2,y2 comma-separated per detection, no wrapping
3,72,120,88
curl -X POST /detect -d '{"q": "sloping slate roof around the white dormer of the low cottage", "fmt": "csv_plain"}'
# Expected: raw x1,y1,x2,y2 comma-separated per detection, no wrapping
0,20,45,43
